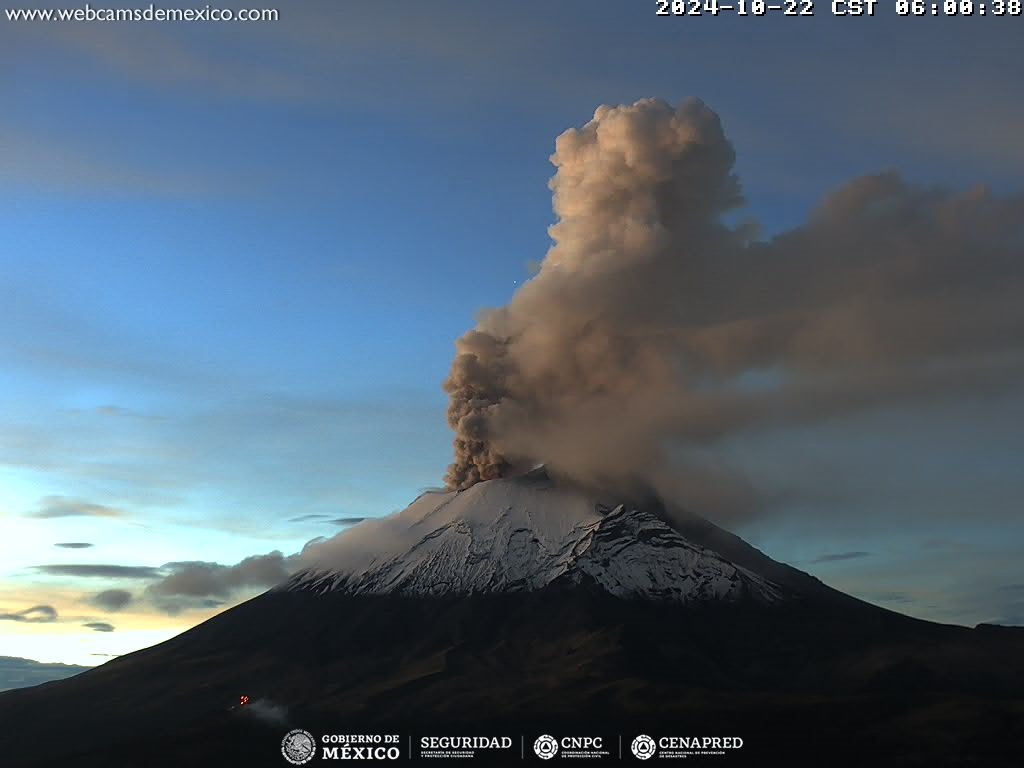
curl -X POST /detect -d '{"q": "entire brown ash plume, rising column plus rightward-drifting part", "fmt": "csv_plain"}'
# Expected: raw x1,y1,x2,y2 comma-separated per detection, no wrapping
444,100,1024,516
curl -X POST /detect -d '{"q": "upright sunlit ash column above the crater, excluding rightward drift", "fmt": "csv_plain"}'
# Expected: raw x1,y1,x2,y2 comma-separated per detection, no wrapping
444,99,741,488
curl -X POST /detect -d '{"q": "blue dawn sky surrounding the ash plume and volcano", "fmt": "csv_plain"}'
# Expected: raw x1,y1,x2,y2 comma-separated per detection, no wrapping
0,0,1024,664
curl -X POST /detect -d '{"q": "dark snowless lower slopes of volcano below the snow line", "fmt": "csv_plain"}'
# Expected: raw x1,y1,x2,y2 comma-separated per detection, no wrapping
0,588,1024,768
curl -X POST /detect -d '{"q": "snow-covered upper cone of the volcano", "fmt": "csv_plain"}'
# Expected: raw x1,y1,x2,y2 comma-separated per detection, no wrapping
282,472,785,601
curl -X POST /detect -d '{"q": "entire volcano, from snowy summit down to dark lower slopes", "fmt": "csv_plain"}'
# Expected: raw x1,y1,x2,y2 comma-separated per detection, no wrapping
0,471,1024,766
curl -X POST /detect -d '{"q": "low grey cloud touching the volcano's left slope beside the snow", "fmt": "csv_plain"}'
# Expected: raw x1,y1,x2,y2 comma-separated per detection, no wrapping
145,552,292,614
